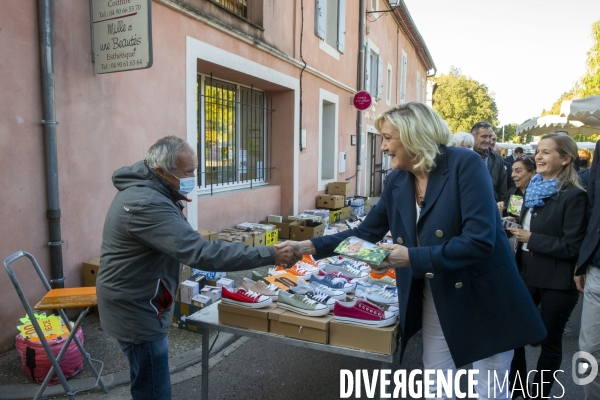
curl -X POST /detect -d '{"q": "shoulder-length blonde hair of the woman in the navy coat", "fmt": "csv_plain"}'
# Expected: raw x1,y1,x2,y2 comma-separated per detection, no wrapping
375,101,452,173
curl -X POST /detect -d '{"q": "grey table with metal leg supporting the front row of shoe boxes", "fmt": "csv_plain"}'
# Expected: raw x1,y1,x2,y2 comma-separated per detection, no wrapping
186,303,398,399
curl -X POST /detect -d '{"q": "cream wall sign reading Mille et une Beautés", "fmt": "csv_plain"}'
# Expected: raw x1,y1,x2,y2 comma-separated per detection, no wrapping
91,0,152,74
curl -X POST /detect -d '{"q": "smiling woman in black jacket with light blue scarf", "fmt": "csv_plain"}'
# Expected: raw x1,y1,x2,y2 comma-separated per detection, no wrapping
508,133,588,397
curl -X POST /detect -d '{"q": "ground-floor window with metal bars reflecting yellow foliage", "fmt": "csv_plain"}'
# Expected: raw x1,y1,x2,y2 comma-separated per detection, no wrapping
198,75,273,194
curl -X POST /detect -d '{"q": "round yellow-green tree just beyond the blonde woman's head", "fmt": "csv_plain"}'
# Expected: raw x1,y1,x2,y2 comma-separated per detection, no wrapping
433,67,498,133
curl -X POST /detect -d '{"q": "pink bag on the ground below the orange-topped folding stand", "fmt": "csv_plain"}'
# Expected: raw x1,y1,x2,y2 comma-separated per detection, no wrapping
15,327,83,385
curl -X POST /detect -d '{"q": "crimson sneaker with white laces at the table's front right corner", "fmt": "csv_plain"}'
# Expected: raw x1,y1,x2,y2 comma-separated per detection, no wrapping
333,298,398,328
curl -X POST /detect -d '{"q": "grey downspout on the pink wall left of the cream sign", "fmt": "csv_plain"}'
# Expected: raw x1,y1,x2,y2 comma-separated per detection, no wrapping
38,0,65,288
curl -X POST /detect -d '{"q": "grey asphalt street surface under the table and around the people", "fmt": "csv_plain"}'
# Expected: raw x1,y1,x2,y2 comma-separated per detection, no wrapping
0,262,583,400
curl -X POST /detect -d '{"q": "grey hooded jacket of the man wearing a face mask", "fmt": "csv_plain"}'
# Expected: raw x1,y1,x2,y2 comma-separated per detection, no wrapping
96,161,275,343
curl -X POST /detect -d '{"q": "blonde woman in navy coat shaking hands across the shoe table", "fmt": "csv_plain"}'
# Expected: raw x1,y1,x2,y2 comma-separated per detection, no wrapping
284,102,546,399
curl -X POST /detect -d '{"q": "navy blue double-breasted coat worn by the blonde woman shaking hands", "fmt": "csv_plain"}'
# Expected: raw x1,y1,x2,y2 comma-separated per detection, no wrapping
311,146,546,367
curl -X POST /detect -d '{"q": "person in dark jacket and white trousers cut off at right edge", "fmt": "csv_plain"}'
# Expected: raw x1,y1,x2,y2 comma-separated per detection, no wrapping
574,141,600,400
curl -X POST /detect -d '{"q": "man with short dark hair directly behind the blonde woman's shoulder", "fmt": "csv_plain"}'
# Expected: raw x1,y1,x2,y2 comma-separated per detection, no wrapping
471,121,507,202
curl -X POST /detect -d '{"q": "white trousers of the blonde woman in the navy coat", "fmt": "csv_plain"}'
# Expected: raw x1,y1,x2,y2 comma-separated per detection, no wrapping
422,280,514,400
